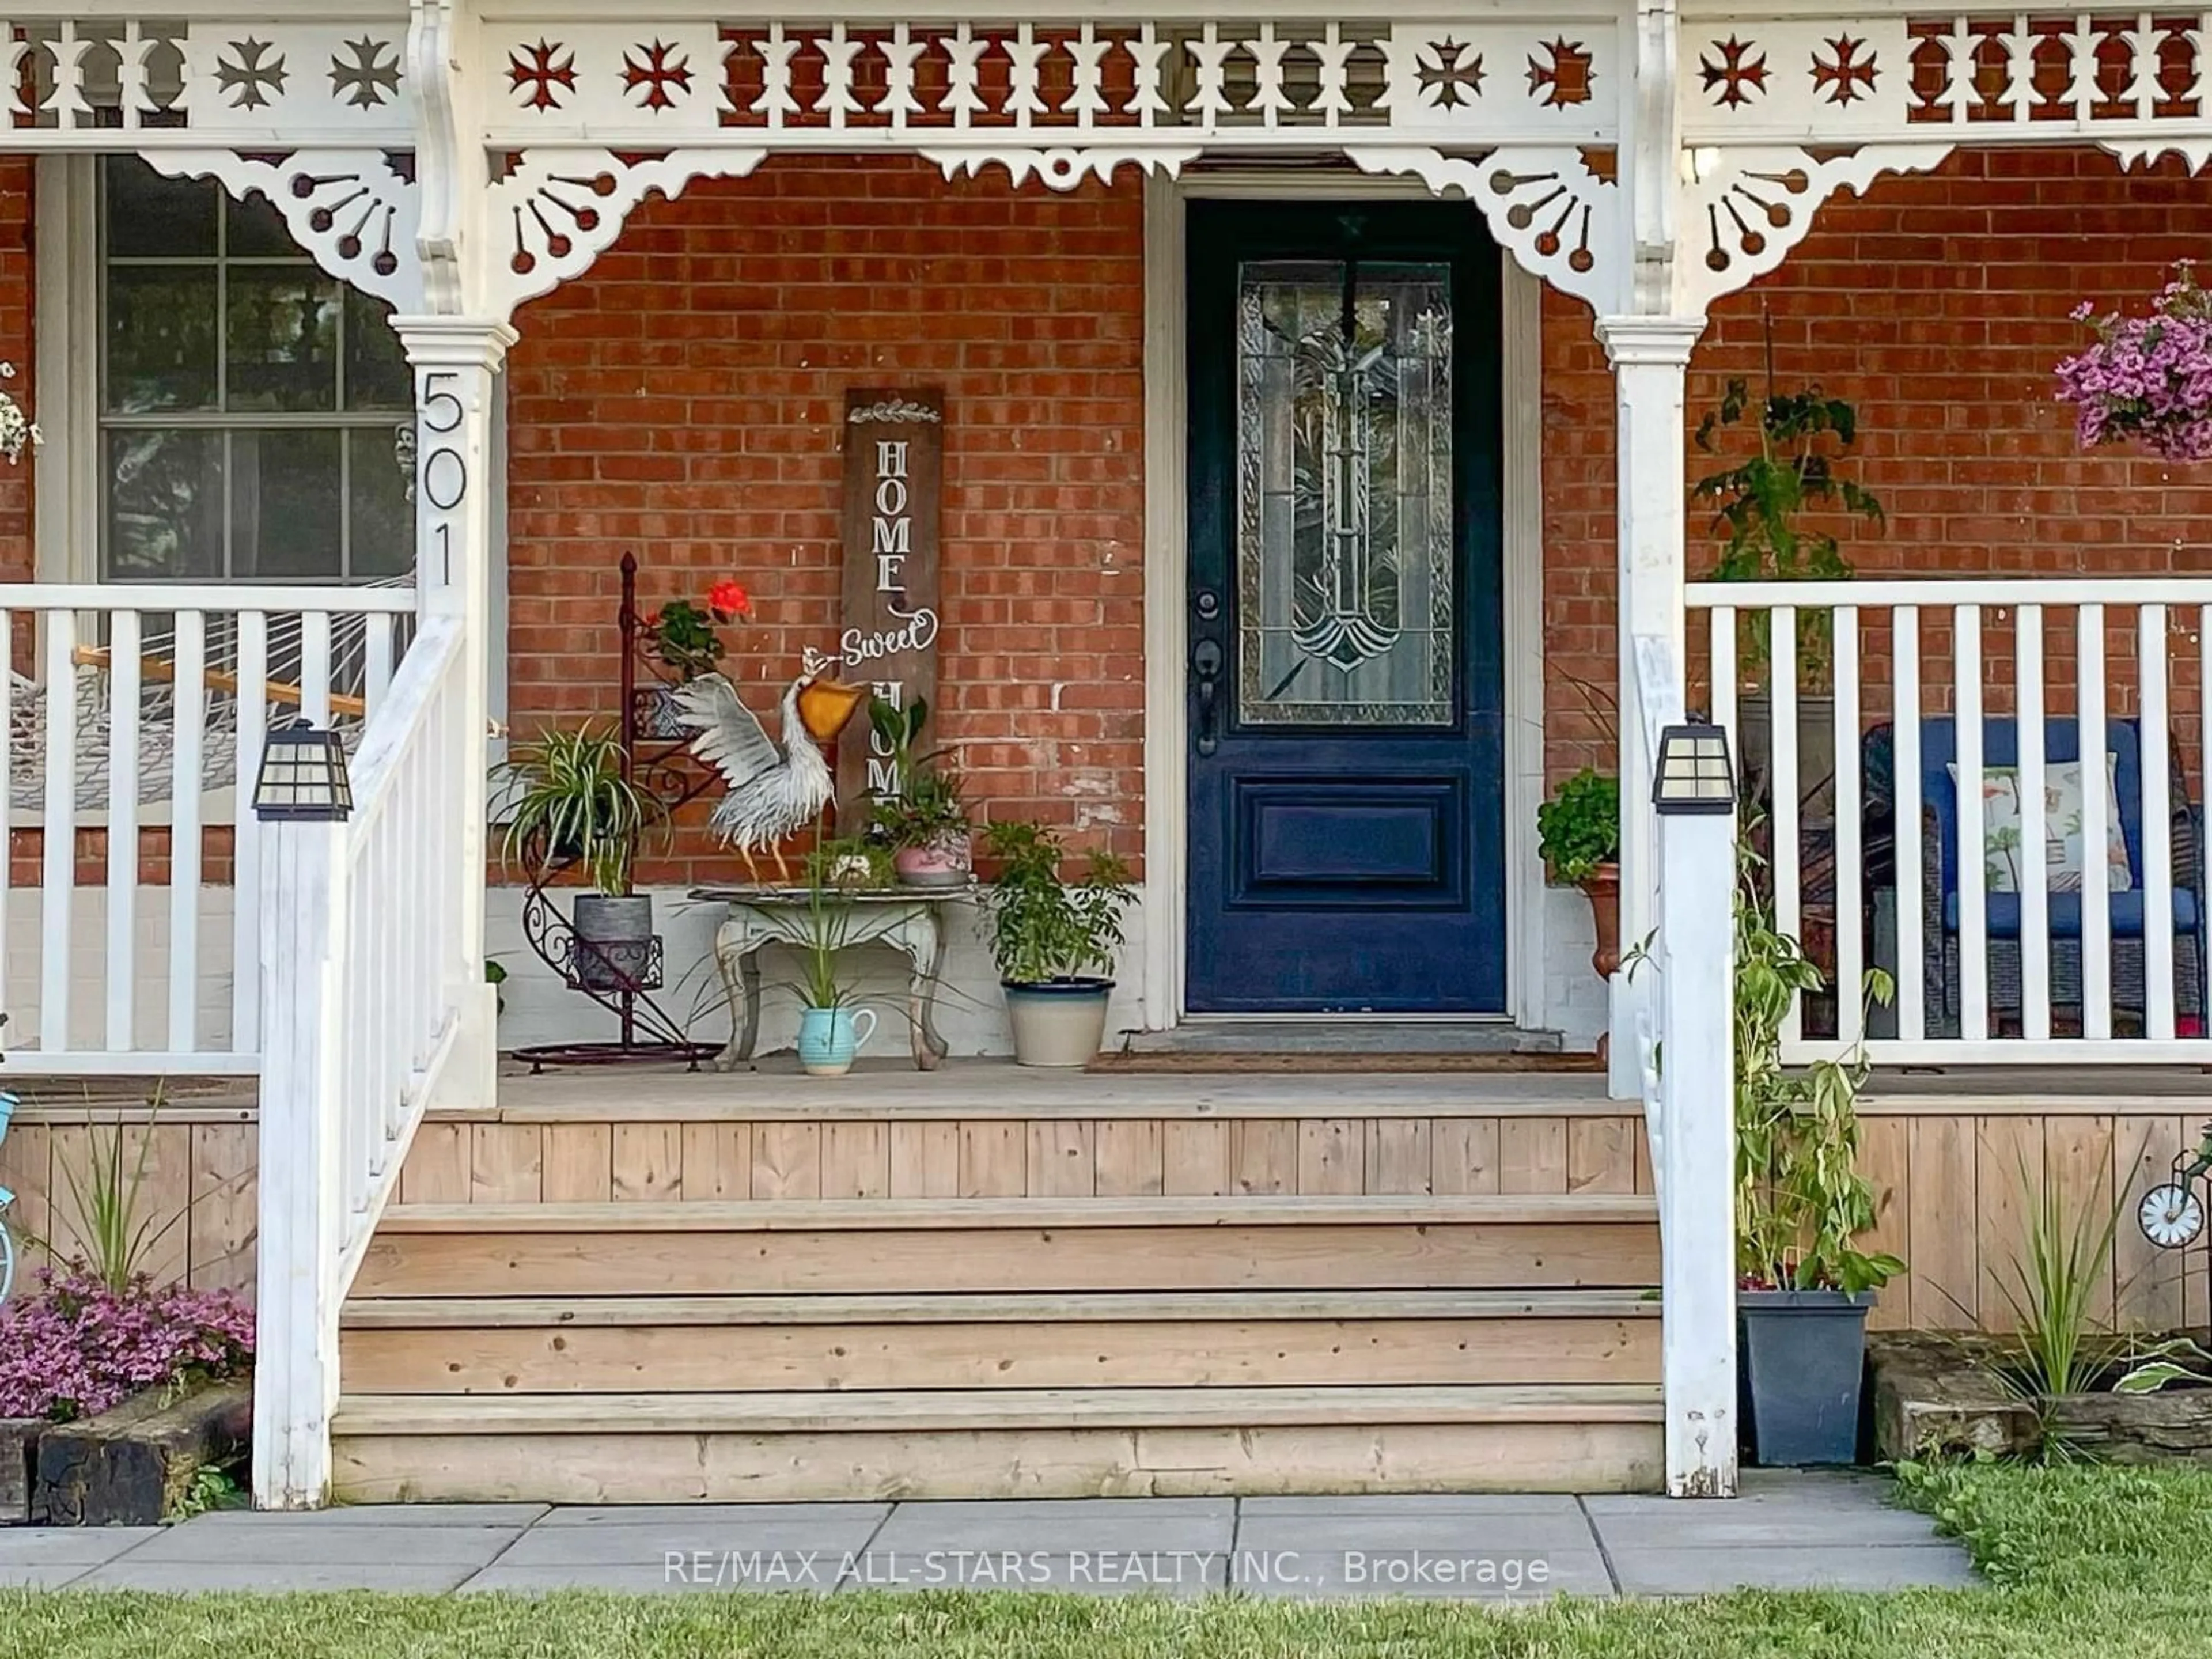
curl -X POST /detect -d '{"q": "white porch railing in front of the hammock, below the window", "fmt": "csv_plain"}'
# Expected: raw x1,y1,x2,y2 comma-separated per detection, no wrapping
0,584,416,1075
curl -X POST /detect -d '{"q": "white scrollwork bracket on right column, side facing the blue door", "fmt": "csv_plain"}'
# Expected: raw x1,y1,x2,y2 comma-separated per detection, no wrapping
1345,146,1628,316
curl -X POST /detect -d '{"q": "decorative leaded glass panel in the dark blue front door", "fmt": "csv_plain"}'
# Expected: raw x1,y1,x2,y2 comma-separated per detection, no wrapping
1237,259,1458,728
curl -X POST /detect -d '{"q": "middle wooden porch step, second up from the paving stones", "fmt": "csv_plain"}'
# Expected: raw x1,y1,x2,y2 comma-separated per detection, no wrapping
340,1290,1659,1396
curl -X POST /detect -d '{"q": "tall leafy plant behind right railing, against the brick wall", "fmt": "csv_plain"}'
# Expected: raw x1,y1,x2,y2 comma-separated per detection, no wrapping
1690,319,1883,816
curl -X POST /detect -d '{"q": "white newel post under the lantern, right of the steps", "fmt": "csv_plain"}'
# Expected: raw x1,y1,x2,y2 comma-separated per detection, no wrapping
1657,812,1736,1498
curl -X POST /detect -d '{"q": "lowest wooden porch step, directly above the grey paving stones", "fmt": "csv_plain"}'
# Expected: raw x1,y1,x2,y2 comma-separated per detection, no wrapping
332,1385,1664,1502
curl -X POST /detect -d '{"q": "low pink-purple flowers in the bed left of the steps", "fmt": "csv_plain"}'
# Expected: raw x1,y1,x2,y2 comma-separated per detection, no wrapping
0,1267,255,1422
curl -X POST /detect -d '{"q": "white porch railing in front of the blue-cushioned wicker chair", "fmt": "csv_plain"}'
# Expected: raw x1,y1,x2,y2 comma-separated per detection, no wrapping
1688,577,2212,1064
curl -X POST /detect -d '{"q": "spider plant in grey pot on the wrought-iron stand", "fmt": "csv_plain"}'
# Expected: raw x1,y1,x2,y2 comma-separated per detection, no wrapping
495,721,666,991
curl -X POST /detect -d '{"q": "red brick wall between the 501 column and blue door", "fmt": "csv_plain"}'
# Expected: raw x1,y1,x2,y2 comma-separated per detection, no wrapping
509,159,1143,882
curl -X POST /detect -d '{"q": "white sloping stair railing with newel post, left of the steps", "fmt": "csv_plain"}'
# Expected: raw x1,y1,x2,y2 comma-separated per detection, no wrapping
255,615,482,1509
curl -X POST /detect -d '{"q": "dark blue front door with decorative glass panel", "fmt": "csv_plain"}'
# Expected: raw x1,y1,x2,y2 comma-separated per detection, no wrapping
1185,201,1506,1013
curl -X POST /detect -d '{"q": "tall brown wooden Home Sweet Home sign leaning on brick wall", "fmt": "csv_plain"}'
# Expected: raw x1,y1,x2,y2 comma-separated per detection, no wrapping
838,387,945,830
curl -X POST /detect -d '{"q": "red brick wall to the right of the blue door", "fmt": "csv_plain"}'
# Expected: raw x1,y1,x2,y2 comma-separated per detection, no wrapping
1544,148,2212,777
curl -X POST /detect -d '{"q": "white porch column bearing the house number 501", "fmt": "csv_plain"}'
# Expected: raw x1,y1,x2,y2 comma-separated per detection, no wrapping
392,316,518,1111
